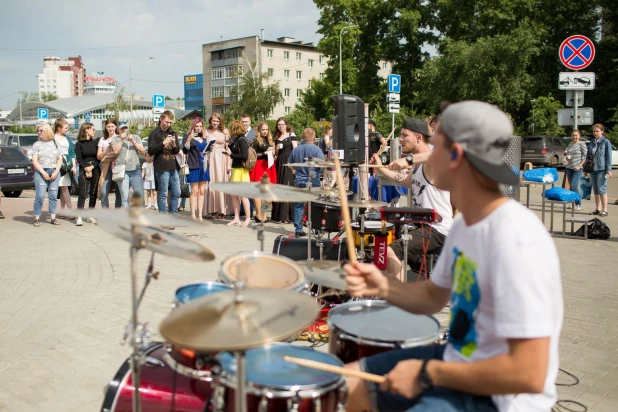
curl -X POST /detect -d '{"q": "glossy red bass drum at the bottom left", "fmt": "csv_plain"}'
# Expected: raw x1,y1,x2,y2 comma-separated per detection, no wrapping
101,343,212,412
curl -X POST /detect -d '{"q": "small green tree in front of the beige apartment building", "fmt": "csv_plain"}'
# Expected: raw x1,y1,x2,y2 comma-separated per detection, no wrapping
225,63,283,122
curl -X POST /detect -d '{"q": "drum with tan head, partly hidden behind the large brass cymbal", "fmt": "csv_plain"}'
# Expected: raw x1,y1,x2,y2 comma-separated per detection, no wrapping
219,252,307,292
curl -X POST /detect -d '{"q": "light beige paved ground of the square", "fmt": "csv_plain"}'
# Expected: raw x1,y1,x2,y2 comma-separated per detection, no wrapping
0,175,618,412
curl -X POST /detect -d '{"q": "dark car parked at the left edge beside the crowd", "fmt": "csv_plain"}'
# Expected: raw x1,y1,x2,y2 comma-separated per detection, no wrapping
0,146,34,197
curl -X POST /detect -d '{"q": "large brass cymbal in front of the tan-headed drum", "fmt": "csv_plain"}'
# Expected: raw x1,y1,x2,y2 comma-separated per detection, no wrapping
159,288,318,352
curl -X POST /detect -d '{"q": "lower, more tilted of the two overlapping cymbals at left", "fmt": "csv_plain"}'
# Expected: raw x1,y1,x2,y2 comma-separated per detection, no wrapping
97,220,215,262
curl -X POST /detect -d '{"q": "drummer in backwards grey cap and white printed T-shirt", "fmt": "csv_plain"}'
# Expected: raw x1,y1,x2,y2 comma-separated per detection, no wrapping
345,101,563,412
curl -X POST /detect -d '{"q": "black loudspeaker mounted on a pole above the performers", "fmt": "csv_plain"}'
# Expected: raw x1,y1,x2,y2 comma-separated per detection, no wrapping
332,94,365,165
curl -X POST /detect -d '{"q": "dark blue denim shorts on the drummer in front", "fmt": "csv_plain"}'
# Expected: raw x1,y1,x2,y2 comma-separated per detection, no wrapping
360,345,498,412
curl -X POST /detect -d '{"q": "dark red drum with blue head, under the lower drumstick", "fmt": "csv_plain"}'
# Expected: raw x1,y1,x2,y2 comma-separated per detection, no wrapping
213,343,347,412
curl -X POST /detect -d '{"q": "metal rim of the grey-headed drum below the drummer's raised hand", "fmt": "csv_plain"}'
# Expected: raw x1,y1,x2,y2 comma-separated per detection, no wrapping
326,300,441,349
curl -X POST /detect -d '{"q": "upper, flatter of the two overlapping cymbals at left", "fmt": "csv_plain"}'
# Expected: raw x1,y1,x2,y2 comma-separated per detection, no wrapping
71,208,201,227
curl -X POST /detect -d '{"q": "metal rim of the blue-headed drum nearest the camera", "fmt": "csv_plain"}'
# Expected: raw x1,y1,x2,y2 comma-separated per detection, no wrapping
217,342,345,392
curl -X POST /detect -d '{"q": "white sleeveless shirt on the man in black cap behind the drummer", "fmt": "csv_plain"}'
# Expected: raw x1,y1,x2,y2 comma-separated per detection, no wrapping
411,165,453,236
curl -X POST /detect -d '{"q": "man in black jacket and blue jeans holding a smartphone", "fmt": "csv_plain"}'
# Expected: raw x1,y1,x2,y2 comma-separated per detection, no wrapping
148,110,180,215
